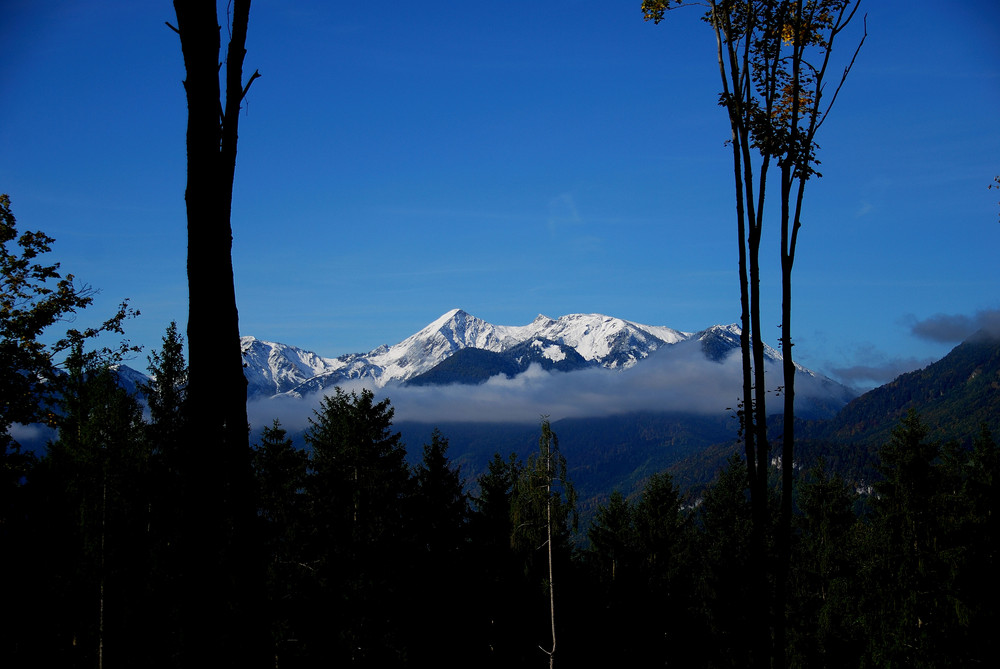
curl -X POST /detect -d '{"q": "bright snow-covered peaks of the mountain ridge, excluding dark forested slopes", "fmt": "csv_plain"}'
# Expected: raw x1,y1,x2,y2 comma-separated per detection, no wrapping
242,309,691,396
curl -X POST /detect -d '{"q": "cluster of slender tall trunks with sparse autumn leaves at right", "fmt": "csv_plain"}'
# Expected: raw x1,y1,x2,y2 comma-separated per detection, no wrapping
642,0,864,666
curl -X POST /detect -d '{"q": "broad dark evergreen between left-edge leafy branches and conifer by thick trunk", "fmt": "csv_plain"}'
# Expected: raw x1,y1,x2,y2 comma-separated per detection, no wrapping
38,348,156,666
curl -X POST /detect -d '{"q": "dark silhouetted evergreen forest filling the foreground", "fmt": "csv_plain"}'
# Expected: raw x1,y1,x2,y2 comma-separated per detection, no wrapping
0,358,998,667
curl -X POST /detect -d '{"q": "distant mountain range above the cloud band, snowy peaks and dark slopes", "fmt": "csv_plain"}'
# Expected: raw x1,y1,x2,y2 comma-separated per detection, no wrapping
234,309,853,418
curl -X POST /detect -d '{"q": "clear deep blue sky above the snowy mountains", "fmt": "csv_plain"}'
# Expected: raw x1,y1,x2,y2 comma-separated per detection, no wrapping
0,0,1000,386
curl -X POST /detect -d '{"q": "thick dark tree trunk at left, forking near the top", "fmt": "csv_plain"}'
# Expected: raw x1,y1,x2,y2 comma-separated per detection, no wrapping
174,0,258,666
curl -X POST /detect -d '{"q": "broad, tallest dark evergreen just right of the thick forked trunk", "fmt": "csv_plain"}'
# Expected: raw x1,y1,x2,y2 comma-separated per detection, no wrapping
305,388,413,666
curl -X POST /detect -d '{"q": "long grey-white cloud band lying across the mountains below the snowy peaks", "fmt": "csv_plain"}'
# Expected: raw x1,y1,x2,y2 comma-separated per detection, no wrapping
250,341,848,430
